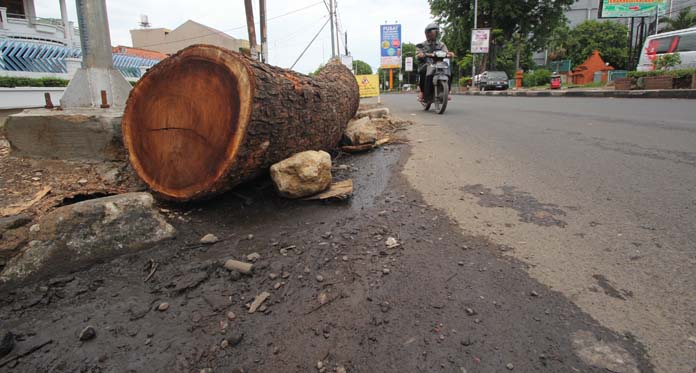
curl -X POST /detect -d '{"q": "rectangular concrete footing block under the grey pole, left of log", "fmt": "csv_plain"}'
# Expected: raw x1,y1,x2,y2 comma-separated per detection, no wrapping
3,109,125,161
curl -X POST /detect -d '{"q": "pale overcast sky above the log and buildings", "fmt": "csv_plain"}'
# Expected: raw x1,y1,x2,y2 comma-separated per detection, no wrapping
36,0,432,73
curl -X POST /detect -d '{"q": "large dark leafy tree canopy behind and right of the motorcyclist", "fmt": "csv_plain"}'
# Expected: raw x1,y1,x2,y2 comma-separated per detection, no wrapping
428,0,575,71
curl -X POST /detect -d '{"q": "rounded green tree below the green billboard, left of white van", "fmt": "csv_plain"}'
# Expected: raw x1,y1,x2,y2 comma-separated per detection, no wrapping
567,20,628,69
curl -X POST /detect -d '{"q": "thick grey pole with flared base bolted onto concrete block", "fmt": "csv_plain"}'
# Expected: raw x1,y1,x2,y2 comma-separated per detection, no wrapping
60,0,131,108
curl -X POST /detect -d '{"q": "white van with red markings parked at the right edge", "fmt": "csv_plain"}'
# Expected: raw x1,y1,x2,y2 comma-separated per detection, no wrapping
638,27,696,71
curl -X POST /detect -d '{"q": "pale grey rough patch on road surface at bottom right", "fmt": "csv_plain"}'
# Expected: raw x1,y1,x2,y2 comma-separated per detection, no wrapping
572,330,640,373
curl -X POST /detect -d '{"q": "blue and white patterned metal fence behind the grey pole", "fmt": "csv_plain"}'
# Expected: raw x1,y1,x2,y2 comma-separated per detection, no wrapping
0,39,159,78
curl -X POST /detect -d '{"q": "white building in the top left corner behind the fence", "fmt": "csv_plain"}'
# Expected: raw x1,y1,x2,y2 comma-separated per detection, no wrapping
0,0,80,48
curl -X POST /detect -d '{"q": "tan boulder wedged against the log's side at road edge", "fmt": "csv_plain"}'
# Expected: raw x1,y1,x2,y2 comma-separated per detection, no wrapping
271,150,331,198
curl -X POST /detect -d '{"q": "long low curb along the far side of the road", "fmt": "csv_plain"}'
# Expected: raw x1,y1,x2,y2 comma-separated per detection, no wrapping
452,89,696,99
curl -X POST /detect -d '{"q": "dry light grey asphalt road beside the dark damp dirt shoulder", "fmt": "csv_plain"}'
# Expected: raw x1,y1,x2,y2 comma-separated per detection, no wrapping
383,95,696,373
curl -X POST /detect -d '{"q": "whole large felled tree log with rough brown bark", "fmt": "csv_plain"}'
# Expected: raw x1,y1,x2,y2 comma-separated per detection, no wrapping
122,45,359,201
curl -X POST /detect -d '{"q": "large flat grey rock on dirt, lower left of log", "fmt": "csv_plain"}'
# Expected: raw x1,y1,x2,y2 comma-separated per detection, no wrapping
0,193,176,284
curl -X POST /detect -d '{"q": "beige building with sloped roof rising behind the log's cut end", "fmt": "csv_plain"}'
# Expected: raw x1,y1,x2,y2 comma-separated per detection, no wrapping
130,20,249,55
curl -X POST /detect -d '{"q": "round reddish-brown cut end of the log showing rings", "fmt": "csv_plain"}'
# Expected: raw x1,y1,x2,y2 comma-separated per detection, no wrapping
122,45,254,201
